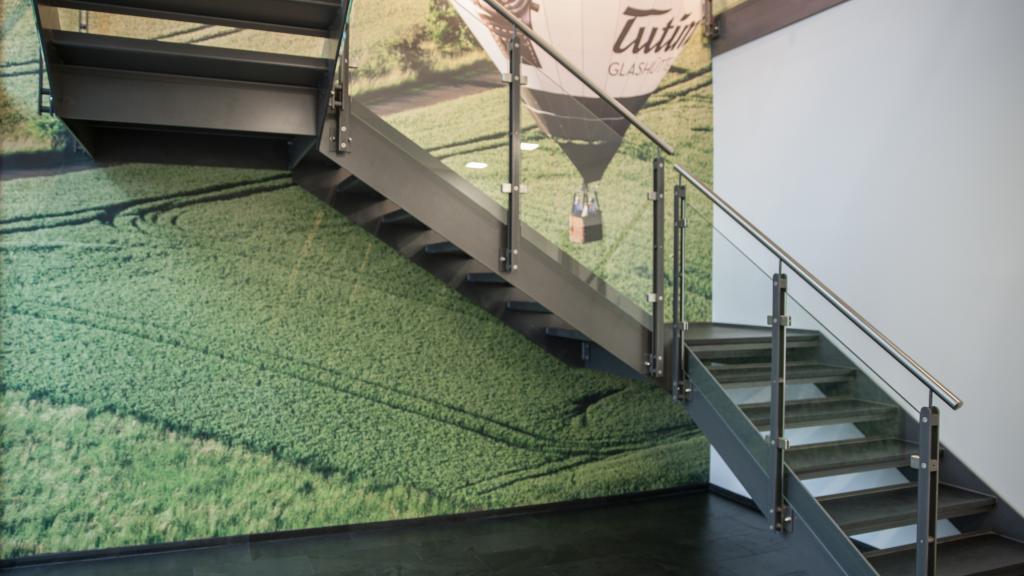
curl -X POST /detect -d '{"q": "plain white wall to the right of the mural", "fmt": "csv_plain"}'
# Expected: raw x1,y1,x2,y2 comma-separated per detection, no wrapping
713,0,1024,510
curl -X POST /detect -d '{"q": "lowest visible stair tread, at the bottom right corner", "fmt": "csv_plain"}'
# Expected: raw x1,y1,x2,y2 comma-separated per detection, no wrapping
864,532,1024,576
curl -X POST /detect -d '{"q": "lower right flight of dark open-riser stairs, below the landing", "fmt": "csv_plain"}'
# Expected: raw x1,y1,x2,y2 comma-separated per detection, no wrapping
687,325,1024,576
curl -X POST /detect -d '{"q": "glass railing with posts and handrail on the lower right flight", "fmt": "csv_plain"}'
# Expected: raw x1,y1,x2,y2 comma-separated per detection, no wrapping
676,161,963,570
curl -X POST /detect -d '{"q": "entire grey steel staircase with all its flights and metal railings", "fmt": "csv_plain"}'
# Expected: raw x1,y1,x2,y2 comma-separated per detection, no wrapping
29,0,1024,576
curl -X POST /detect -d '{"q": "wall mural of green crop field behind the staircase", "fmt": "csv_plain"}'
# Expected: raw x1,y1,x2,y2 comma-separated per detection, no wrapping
0,0,711,559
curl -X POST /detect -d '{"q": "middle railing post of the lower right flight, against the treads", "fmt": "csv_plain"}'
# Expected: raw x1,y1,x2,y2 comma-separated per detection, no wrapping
768,274,793,532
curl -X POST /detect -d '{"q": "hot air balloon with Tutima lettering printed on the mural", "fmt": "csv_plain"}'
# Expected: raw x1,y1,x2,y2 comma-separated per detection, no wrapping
449,0,702,243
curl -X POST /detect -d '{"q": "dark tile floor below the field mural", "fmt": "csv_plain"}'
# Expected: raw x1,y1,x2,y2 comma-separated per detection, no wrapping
7,491,805,576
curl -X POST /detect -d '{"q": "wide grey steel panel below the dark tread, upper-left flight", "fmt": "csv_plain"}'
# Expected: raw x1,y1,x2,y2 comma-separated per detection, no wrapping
50,66,317,136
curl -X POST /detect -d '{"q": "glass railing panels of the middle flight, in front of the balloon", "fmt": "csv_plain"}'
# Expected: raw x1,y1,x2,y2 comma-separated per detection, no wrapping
339,0,708,325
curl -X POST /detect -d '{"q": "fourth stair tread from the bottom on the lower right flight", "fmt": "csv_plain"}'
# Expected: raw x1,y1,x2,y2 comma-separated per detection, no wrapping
739,397,899,430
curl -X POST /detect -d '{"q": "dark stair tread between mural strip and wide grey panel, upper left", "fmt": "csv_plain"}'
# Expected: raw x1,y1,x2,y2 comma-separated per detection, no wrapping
50,31,330,87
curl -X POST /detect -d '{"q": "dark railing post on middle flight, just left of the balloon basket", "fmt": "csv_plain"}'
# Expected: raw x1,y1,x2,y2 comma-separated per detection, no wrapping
500,32,524,272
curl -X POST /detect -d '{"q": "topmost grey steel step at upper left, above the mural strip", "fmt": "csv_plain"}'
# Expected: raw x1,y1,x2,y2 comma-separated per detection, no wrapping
40,0,339,36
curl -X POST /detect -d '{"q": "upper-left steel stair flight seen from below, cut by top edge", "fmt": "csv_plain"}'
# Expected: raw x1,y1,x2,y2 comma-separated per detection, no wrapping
35,0,348,166
